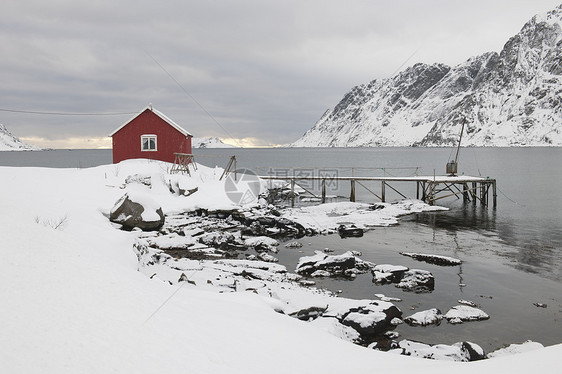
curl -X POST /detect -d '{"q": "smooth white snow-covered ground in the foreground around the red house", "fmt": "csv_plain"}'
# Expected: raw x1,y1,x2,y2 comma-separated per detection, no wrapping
0,160,562,373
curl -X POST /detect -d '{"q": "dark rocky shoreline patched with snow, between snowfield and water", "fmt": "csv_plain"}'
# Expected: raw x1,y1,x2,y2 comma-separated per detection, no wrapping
108,184,524,361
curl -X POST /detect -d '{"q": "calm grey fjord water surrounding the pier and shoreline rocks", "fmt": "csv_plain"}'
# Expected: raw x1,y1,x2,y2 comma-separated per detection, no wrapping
0,148,562,352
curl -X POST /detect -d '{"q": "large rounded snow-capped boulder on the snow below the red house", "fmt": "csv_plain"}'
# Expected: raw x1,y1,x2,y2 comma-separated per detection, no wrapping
109,192,165,231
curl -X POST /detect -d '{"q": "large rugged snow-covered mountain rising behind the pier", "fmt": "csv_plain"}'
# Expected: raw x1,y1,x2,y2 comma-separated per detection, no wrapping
291,5,562,147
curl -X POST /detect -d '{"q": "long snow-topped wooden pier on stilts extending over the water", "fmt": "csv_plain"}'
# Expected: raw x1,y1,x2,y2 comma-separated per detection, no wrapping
260,175,497,208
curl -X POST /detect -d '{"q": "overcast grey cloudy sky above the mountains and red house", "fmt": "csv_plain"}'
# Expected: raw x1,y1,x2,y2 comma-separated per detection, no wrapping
0,0,561,148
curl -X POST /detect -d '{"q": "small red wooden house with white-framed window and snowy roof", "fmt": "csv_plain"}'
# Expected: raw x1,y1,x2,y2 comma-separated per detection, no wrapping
109,105,192,164
